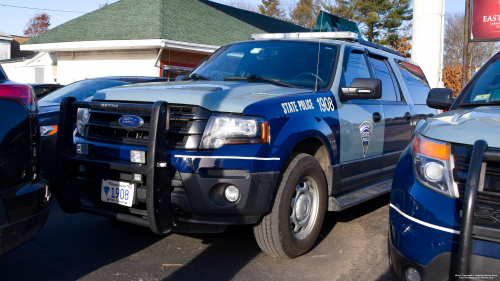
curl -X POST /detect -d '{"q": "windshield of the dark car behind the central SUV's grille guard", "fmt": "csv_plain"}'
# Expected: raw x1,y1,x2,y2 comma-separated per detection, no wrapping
40,80,130,103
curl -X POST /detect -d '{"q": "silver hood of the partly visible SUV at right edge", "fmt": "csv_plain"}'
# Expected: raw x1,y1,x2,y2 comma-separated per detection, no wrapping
419,106,500,148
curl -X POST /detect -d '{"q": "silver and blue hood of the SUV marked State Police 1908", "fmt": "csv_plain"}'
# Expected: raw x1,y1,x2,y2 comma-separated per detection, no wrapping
93,81,311,113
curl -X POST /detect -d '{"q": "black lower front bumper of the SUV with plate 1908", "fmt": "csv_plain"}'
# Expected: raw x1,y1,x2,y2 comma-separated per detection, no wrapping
72,156,279,223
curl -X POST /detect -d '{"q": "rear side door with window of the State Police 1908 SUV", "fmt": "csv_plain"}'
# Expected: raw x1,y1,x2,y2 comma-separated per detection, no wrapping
369,53,413,176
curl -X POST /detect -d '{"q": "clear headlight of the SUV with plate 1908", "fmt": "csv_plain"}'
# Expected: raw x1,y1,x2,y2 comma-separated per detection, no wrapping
200,114,269,149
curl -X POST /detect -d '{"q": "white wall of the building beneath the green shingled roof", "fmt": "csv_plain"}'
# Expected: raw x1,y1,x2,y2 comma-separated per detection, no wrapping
57,49,160,84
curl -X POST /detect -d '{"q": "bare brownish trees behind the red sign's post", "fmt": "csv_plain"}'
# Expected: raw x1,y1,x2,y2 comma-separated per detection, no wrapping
443,12,499,72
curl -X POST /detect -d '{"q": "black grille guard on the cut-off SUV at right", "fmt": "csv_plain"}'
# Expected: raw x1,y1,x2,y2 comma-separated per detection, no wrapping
457,140,500,276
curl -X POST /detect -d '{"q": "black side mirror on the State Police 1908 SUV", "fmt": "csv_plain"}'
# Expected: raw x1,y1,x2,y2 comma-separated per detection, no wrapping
339,78,382,102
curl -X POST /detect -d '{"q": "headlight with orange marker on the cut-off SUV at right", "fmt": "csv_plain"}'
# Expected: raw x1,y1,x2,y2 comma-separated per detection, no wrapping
412,134,458,198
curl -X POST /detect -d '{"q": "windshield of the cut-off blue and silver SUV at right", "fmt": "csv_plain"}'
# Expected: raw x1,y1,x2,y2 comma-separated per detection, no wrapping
459,56,500,105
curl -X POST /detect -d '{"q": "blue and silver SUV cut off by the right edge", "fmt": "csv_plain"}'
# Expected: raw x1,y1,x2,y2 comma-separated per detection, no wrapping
389,50,500,281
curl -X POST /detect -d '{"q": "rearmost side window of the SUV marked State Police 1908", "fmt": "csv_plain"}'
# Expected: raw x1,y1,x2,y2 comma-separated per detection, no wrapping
396,60,430,104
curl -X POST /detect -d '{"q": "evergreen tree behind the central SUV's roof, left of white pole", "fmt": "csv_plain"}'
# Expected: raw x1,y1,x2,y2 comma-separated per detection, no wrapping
323,0,413,46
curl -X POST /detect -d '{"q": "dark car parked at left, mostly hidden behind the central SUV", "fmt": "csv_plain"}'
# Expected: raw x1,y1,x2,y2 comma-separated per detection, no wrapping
38,76,168,181
